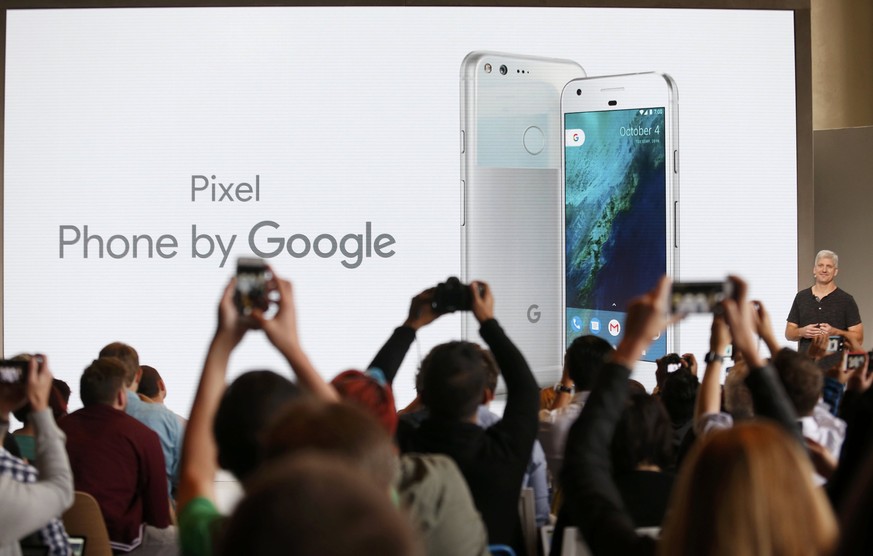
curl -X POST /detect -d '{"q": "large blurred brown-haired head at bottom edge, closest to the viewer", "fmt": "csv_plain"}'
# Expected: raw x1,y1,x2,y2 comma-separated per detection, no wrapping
216,454,422,556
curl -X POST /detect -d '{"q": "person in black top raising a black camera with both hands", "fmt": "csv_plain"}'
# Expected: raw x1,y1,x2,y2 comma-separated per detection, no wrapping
371,282,539,554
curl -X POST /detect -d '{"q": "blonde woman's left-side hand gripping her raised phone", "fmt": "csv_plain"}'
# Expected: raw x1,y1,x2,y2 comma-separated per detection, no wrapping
612,276,670,369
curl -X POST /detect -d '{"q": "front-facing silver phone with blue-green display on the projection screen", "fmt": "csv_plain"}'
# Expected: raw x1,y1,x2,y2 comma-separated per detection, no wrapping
561,73,679,361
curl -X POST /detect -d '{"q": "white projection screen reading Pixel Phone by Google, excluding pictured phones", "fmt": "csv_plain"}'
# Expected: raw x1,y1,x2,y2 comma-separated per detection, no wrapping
2,2,811,415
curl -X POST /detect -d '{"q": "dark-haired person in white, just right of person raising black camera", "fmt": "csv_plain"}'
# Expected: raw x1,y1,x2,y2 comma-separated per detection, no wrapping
537,335,612,478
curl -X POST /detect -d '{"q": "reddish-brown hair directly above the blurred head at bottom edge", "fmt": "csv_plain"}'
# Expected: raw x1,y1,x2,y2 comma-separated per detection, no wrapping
264,399,397,492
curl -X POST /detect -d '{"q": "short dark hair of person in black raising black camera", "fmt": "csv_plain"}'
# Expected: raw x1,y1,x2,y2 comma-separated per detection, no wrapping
416,341,488,420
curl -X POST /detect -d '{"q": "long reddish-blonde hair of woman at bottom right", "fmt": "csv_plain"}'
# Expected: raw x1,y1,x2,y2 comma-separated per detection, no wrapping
659,421,837,556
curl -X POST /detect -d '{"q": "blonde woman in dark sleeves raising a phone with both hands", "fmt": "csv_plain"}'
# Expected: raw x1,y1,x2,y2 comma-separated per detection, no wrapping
552,278,836,556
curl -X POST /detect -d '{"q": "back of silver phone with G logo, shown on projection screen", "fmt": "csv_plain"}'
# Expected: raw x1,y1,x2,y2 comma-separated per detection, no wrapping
461,51,585,383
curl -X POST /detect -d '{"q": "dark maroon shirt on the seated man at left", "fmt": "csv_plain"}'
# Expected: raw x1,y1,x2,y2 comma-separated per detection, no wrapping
58,404,170,552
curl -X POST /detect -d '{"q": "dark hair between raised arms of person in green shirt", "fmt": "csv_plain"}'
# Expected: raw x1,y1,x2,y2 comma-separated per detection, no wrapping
213,371,300,480
